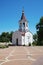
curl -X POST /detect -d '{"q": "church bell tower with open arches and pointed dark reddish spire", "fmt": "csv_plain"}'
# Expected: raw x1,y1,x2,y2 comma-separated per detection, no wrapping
19,10,28,32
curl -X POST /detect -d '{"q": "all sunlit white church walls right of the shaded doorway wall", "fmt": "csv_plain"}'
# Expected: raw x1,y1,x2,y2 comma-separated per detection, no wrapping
22,32,33,45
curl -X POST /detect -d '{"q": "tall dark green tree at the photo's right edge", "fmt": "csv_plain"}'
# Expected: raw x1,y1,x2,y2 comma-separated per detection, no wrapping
36,17,43,45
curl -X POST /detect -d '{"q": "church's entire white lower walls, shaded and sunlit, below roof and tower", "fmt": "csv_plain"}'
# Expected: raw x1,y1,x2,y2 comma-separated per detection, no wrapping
12,31,33,45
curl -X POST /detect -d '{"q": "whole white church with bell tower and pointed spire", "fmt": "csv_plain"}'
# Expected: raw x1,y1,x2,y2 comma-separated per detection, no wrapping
12,11,33,46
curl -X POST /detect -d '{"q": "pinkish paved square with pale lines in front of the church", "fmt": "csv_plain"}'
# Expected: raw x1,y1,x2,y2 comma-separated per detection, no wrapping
0,46,43,65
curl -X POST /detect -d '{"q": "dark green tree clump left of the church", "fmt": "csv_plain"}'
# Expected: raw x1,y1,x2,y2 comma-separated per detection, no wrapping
0,32,13,42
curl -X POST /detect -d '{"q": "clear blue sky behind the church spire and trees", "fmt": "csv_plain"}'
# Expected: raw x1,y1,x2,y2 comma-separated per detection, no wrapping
0,0,43,34
